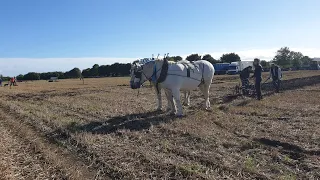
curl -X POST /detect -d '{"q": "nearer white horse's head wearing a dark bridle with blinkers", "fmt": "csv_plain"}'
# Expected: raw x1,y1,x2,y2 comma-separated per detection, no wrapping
130,61,154,89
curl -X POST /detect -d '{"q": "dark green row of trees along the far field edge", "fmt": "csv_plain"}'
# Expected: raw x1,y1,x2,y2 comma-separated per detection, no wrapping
2,47,315,80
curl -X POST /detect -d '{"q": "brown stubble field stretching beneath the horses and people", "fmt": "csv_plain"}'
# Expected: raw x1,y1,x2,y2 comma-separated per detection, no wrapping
0,71,320,179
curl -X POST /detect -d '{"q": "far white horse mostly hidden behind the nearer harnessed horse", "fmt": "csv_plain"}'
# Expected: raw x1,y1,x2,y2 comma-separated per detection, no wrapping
130,60,190,111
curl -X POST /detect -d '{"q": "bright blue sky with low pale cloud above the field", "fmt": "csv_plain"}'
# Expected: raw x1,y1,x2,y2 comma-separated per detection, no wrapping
0,0,320,75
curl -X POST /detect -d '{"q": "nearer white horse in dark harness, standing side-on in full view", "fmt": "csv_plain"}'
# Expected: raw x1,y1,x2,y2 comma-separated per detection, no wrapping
130,60,215,116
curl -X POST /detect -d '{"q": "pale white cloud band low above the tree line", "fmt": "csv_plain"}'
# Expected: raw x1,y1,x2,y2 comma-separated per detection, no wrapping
0,48,320,76
